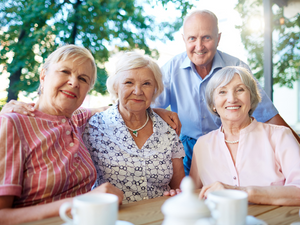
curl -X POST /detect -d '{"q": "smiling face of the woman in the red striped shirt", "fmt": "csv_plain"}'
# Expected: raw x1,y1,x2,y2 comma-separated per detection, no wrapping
37,59,93,117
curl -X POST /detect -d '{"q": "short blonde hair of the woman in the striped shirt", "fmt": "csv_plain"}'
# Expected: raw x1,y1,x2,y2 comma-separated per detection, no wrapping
38,45,97,94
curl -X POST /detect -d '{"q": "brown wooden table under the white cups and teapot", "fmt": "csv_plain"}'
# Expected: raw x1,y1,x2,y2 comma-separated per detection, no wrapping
24,197,300,225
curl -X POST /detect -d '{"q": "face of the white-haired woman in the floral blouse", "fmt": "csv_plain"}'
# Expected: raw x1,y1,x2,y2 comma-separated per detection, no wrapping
116,67,156,113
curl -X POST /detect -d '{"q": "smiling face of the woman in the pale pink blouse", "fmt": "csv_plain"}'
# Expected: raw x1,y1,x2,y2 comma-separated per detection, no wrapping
214,74,251,124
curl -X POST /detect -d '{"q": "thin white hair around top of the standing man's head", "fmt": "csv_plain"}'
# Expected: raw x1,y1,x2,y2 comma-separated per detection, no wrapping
183,9,219,34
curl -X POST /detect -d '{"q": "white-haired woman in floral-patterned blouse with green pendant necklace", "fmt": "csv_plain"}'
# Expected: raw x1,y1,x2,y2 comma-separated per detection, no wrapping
83,52,185,203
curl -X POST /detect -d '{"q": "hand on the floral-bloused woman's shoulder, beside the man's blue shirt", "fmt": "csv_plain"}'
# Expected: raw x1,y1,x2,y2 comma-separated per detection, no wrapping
153,108,181,136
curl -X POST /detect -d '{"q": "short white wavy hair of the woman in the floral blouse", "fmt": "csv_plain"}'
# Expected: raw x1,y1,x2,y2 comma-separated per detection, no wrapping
106,52,164,102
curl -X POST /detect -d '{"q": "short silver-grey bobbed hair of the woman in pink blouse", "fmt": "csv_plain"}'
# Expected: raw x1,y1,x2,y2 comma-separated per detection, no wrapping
205,66,261,116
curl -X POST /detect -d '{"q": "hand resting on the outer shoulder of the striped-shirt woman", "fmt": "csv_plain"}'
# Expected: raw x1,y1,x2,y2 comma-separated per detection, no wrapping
0,100,35,116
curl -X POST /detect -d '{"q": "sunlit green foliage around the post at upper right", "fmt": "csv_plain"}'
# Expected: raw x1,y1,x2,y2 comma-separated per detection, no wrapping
235,0,300,88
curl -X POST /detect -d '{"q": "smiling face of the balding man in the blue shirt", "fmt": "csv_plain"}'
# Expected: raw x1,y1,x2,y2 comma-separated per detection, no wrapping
183,13,221,74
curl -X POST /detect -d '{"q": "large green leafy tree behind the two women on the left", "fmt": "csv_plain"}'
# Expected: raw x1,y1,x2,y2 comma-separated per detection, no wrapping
0,0,192,100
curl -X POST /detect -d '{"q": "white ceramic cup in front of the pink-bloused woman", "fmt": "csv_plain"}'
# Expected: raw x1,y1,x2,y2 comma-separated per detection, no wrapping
206,190,248,225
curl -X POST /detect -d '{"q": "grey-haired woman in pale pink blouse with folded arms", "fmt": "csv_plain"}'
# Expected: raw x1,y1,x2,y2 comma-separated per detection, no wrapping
190,67,300,205
